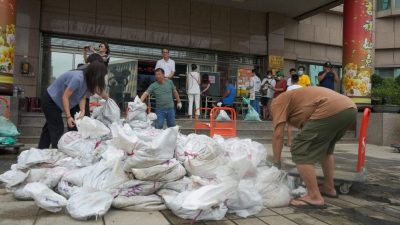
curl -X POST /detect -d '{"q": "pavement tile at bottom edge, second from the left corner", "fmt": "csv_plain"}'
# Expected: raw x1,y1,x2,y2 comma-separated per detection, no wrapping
35,209,103,225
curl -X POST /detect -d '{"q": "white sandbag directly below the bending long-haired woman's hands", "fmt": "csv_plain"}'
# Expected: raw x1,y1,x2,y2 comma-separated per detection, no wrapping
75,116,110,139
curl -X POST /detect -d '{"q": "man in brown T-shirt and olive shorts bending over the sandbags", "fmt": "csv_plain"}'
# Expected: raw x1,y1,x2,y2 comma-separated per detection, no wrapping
272,87,357,209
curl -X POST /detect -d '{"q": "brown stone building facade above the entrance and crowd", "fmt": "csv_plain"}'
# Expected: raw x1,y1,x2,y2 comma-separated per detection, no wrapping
3,0,400,97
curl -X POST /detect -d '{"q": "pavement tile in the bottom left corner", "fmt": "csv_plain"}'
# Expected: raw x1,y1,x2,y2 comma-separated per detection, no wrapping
0,201,39,225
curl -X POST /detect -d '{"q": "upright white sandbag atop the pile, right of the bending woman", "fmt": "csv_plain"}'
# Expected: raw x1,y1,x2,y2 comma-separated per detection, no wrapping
92,98,121,126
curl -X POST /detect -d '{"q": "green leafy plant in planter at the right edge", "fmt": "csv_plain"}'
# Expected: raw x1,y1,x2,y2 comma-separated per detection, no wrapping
371,75,400,113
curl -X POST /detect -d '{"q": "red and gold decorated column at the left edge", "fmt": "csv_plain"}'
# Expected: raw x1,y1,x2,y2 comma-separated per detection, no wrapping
0,0,16,94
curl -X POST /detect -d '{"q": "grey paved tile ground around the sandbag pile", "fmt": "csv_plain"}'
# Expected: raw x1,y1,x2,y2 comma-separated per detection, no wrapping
0,144,400,225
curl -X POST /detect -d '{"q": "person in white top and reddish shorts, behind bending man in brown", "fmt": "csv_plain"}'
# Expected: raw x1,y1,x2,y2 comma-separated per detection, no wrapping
260,70,276,120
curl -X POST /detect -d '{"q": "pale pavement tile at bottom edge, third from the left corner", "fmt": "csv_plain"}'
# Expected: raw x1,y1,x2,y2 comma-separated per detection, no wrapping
104,209,170,225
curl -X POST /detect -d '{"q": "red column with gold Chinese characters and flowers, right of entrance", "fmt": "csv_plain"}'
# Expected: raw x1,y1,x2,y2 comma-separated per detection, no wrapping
342,0,375,103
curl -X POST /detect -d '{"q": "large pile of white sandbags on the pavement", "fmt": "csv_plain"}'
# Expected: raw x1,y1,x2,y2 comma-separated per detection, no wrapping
0,98,300,220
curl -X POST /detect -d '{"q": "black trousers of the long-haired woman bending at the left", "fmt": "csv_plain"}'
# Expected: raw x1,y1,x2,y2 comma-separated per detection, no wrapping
38,91,64,149
